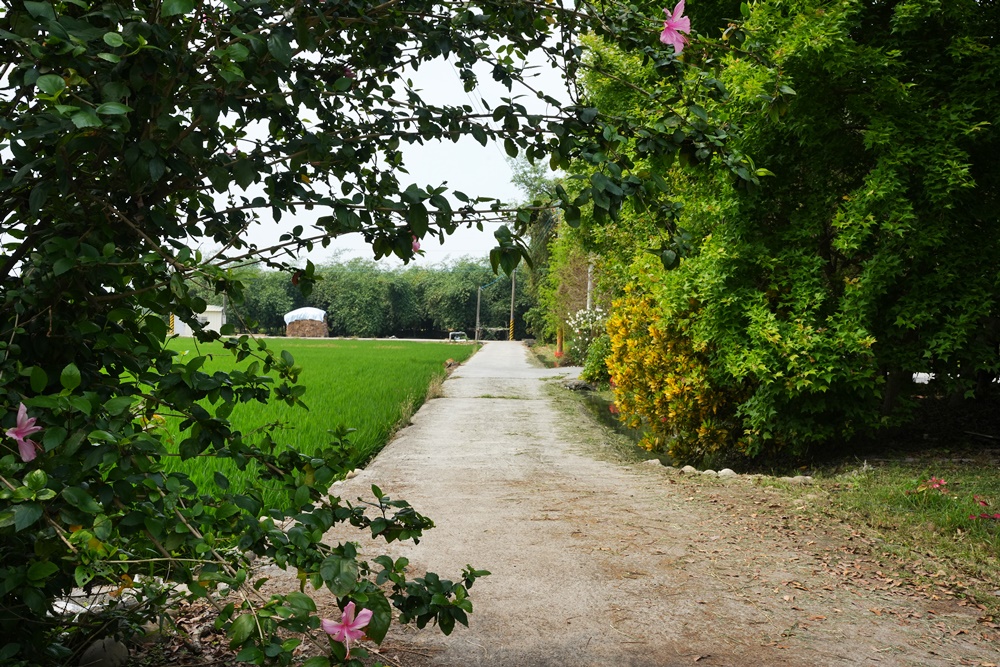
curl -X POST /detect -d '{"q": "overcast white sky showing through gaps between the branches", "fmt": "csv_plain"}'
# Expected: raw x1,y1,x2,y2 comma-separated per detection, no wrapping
233,51,569,265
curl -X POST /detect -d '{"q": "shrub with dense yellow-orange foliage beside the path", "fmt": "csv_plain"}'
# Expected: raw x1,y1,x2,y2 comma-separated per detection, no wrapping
607,284,742,463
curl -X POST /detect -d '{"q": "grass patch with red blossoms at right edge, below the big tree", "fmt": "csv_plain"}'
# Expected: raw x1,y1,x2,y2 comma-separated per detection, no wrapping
824,453,1000,602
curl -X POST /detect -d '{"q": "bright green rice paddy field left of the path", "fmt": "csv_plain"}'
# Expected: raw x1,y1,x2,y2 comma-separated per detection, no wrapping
166,338,475,500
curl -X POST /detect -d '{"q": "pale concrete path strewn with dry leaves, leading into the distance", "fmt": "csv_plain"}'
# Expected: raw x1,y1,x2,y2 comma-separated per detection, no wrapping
292,342,1000,667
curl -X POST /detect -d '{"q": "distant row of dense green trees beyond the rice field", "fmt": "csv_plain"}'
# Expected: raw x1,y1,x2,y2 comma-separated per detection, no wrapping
203,259,533,338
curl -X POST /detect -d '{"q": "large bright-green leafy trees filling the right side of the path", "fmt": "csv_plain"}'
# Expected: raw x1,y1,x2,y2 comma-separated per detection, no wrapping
580,0,1000,462
